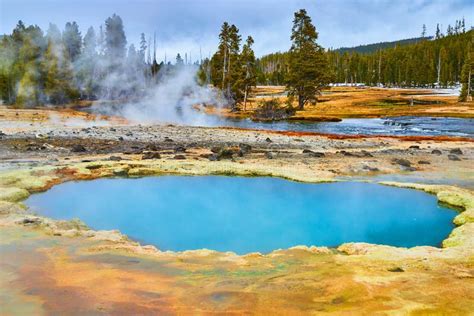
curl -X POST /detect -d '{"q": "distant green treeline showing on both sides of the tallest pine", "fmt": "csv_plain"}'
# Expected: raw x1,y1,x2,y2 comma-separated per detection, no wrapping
257,21,474,87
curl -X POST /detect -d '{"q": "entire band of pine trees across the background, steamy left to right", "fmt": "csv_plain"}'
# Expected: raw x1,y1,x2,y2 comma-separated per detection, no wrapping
0,10,474,110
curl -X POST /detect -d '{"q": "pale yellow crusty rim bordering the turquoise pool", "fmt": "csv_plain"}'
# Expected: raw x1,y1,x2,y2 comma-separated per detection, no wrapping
0,162,474,256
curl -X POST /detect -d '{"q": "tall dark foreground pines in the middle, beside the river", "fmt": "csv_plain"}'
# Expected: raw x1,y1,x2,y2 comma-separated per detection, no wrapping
198,9,331,110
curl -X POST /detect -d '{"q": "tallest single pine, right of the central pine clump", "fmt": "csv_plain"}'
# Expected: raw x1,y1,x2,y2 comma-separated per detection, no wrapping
287,9,330,110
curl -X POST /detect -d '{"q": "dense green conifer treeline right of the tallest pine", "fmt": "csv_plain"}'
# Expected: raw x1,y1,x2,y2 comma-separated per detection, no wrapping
328,31,474,87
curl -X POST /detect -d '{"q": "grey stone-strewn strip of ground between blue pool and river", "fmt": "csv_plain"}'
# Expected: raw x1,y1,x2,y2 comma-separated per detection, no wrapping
0,125,474,188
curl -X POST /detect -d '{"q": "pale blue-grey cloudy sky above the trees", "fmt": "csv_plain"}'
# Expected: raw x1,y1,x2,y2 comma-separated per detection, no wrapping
0,0,474,59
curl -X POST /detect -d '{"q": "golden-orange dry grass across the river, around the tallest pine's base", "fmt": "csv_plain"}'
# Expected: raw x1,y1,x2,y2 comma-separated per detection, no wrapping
206,87,474,120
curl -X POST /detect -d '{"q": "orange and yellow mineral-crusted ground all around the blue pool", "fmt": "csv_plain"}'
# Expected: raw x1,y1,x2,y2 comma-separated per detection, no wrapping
0,108,474,314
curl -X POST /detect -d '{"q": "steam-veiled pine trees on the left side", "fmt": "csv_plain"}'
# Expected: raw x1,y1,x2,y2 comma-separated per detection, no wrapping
0,14,198,107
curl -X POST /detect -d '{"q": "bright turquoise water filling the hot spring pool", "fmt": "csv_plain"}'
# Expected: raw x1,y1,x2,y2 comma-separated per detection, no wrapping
26,176,456,254
